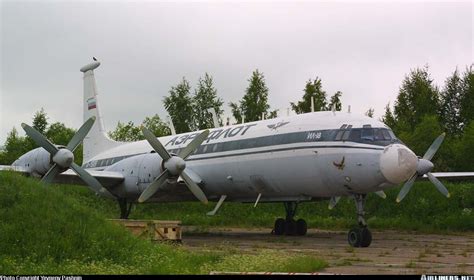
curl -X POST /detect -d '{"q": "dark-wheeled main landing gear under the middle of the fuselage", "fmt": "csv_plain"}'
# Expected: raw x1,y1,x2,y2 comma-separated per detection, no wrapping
272,201,308,235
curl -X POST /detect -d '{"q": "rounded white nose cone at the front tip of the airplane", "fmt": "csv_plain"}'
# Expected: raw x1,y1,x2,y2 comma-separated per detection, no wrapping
380,144,418,184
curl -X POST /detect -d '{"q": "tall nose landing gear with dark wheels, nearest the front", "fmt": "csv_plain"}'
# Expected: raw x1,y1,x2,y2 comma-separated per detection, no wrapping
347,194,372,247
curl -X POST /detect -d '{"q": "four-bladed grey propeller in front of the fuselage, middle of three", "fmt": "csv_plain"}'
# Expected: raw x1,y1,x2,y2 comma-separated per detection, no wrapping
138,126,209,204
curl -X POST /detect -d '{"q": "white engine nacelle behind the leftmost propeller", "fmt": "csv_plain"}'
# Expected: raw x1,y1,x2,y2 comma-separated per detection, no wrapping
12,147,53,176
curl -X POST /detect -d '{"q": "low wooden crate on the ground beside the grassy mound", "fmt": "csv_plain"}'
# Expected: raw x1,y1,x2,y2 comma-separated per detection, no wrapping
110,219,181,242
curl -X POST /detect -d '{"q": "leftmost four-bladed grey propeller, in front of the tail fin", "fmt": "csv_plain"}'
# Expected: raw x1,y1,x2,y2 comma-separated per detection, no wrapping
21,117,115,199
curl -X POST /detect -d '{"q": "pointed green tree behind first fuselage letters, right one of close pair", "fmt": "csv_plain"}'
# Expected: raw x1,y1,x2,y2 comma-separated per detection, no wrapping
194,73,224,129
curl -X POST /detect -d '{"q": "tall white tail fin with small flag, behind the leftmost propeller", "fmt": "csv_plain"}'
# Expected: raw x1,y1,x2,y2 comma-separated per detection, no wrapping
81,60,121,162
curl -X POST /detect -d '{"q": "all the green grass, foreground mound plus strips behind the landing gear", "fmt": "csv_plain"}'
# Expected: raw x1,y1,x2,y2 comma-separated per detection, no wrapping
0,172,474,274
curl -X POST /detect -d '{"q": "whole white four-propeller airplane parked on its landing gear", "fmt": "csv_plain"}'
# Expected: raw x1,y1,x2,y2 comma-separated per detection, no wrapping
0,59,474,247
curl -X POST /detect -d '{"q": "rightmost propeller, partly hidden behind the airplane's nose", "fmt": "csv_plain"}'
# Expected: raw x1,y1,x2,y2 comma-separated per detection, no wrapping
397,133,450,202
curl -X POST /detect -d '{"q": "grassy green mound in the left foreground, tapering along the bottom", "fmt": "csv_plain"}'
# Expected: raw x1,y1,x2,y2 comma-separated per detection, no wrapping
0,172,327,275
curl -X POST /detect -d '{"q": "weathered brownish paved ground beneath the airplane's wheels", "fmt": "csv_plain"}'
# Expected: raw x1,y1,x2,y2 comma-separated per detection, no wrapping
183,227,474,275
